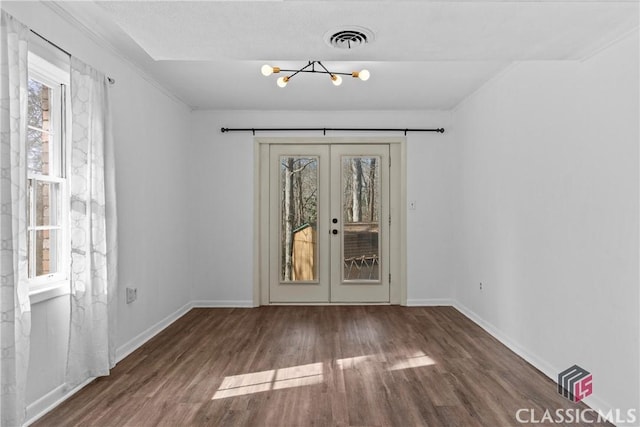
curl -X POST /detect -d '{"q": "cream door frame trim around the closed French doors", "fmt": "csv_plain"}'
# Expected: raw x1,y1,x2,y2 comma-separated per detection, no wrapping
253,137,407,307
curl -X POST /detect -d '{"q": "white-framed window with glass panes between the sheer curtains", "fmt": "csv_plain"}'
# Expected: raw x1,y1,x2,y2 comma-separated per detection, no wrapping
26,54,69,302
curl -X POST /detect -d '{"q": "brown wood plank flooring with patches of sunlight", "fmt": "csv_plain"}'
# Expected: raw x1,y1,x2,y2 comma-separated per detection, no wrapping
34,306,607,427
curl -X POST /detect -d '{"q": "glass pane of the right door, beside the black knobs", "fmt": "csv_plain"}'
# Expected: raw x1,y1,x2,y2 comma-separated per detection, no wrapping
342,156,380,281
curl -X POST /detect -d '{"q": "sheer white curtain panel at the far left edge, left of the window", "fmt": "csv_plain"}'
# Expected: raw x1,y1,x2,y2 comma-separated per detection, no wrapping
0,11,31,427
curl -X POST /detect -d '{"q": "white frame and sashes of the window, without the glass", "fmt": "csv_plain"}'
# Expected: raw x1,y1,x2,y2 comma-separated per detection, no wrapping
26,51,71,304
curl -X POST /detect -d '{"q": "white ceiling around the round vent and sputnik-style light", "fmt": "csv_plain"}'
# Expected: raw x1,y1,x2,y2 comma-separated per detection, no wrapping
52,0,639,110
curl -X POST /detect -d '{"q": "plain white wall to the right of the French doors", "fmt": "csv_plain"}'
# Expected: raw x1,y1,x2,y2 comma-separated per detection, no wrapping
452,32,640,422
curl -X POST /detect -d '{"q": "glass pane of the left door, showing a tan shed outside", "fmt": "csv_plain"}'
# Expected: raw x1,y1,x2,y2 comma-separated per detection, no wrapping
280,156,318,282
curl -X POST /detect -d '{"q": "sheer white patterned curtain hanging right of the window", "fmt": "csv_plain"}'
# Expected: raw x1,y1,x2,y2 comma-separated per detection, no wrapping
66,58,117,386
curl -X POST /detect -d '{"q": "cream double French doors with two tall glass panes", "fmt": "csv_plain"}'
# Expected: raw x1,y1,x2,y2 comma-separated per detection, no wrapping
268,144,390,303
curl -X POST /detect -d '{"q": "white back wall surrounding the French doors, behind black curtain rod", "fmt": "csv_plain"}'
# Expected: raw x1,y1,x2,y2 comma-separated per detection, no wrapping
192,111,453,304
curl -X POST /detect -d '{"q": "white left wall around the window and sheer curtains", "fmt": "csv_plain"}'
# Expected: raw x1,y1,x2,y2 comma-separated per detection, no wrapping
2,2,192,422
